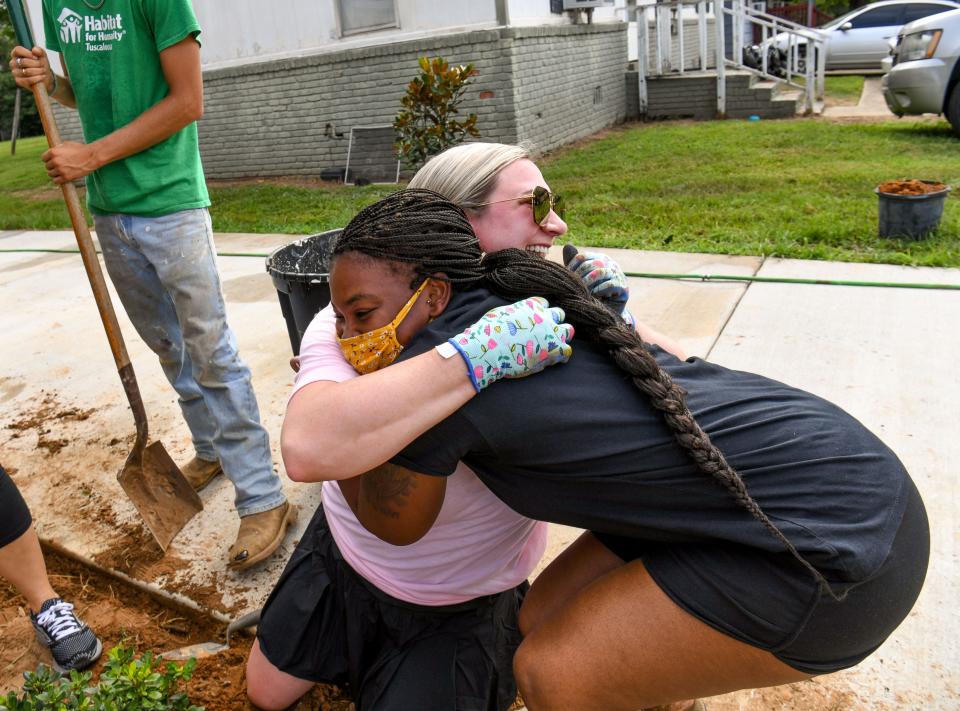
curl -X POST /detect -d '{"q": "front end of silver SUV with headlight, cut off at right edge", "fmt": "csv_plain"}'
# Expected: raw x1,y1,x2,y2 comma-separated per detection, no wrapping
883,10,960,137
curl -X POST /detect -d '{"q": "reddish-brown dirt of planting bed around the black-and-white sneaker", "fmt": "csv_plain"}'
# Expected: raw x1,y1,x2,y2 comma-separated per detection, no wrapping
0,551,353,711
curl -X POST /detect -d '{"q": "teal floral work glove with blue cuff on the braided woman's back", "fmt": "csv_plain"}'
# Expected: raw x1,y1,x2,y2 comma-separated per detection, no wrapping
448,296,573,392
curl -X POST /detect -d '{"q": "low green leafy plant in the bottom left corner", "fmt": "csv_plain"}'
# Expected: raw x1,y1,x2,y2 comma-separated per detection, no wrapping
0,644,203,711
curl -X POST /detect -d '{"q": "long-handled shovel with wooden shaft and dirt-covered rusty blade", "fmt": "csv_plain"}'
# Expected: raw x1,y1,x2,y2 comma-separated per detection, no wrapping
7,0,203,552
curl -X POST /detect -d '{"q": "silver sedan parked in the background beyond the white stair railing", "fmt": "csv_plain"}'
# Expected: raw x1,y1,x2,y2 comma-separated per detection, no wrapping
774,0,960,70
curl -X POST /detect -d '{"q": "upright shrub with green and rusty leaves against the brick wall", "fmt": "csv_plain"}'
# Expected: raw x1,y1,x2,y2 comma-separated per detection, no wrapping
393,57,480,169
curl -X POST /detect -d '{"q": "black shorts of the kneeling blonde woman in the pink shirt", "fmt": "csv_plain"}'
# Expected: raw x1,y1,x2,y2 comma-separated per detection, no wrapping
257,506,528,711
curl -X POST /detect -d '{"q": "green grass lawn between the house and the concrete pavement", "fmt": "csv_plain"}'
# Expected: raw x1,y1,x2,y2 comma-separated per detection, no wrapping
0,117,960,266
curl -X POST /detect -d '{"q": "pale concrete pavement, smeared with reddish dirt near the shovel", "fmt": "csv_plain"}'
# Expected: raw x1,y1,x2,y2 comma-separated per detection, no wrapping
0,232,960,711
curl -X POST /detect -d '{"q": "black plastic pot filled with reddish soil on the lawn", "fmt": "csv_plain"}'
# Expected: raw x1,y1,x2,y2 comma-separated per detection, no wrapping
874,180,950,239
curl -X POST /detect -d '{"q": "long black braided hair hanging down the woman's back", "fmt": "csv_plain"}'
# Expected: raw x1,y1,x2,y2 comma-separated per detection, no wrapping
333,190,845,600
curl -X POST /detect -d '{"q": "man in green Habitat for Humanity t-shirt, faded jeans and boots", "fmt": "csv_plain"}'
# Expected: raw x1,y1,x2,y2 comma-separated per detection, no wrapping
10,0,296,569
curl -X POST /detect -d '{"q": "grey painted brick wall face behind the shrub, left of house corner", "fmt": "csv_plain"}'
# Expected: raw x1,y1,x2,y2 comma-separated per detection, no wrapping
199,31,516,178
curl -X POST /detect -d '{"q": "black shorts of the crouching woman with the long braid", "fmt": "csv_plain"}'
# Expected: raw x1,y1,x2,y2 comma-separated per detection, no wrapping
593,479,930,674
